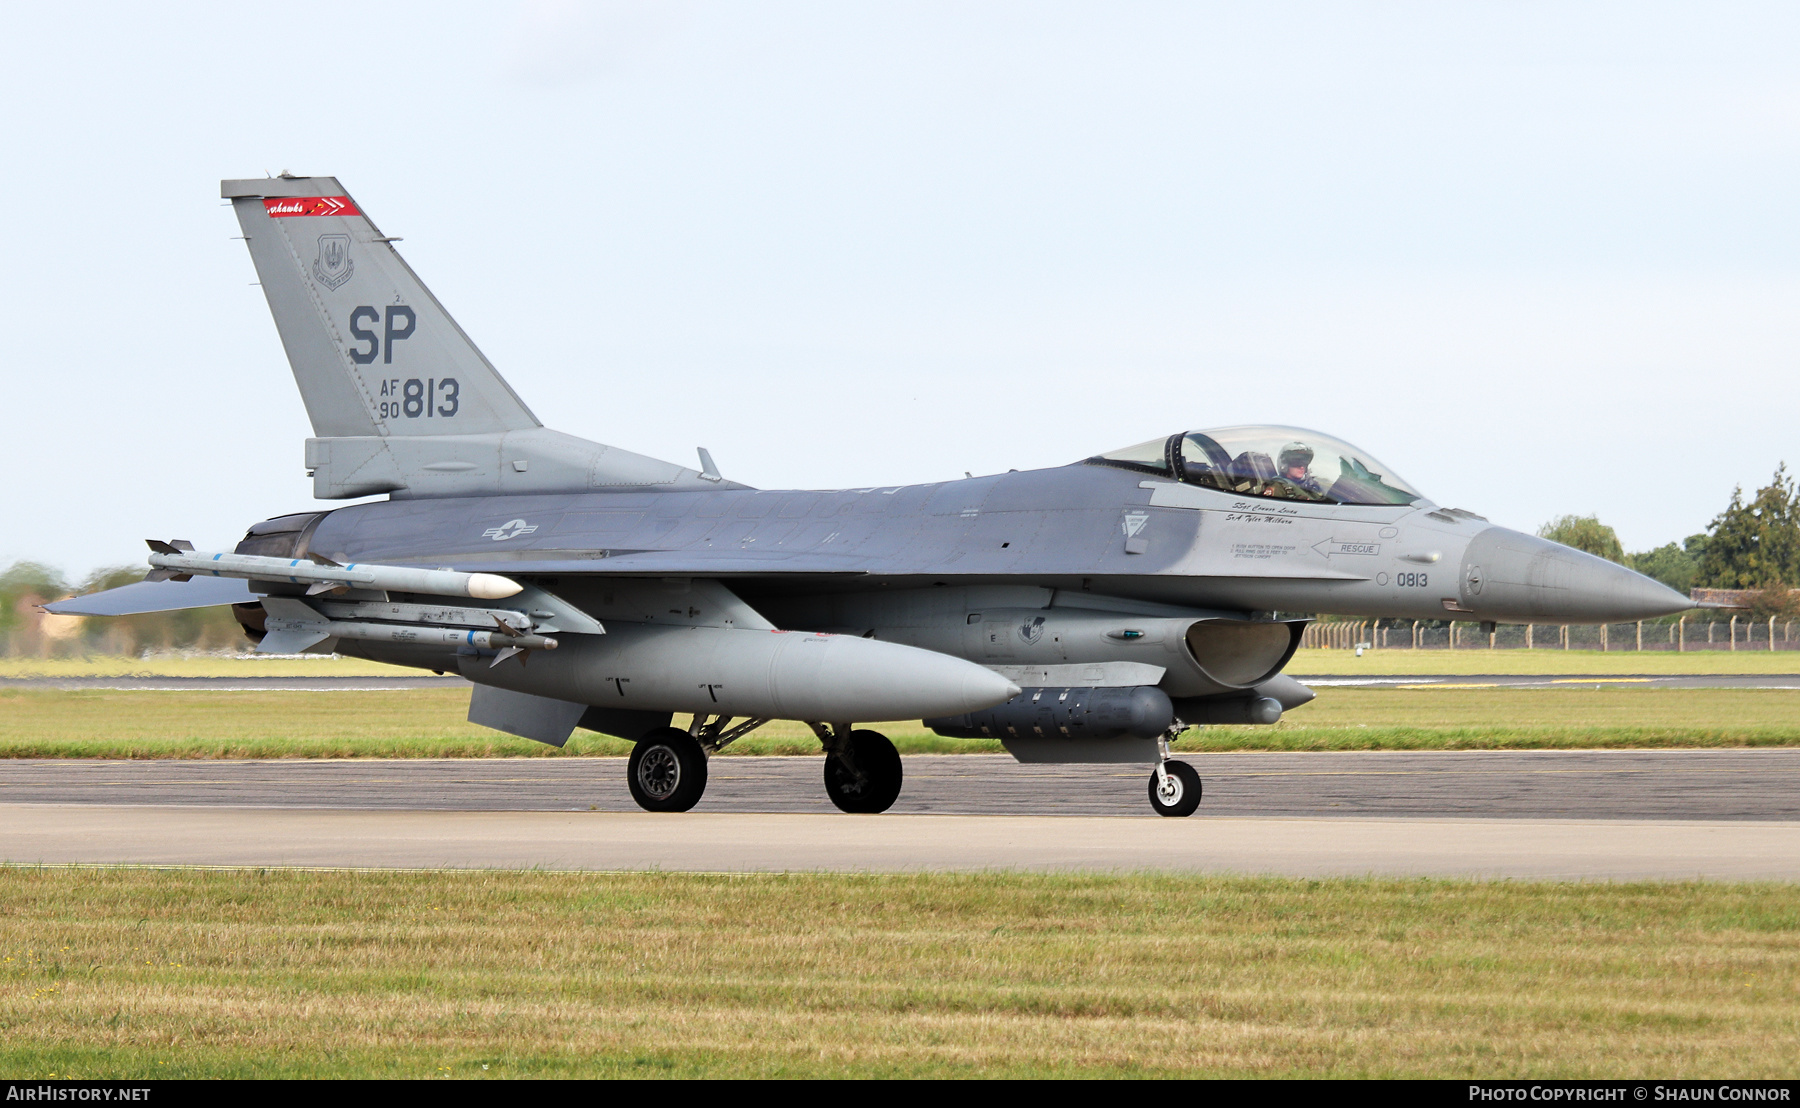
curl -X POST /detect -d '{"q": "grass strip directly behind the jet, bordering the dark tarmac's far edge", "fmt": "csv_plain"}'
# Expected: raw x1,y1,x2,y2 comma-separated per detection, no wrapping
0,684,1800,757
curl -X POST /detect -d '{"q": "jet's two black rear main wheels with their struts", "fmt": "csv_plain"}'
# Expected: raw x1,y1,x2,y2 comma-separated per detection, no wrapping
625,716,904,815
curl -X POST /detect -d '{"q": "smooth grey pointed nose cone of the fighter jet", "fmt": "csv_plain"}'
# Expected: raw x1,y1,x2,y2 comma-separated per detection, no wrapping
1460,527,1694,622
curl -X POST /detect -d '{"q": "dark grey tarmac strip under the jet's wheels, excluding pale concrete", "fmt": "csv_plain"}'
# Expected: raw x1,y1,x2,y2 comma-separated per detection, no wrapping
0,748,1800,822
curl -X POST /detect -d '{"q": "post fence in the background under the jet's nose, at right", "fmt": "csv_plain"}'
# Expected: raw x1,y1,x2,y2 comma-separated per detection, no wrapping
1300,615,1800,653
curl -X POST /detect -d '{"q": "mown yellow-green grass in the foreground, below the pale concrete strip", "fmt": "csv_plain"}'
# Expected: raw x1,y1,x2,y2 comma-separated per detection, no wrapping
0,867,1800,1079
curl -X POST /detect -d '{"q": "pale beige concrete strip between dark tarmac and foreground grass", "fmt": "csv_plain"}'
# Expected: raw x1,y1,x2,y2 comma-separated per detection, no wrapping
0,804,1800,881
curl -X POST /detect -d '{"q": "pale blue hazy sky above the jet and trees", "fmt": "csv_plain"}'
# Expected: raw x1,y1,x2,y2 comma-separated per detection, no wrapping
0,0,1800,577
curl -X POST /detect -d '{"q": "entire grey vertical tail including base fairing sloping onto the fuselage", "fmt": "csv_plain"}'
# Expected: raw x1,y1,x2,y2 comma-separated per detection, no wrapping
220,176,727,498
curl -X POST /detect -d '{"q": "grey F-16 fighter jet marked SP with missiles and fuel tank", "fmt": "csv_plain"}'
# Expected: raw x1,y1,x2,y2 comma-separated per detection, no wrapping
52,176,1692,817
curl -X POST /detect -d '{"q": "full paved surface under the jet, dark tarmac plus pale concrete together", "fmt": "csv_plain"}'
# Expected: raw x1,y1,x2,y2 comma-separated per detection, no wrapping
0,750,1800,881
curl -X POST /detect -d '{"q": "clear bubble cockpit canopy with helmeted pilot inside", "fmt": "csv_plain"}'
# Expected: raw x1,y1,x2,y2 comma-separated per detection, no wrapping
1087,426,1422,504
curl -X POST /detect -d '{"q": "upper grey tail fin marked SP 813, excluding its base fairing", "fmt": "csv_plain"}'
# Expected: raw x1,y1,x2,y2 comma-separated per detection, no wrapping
221,176,542,437
